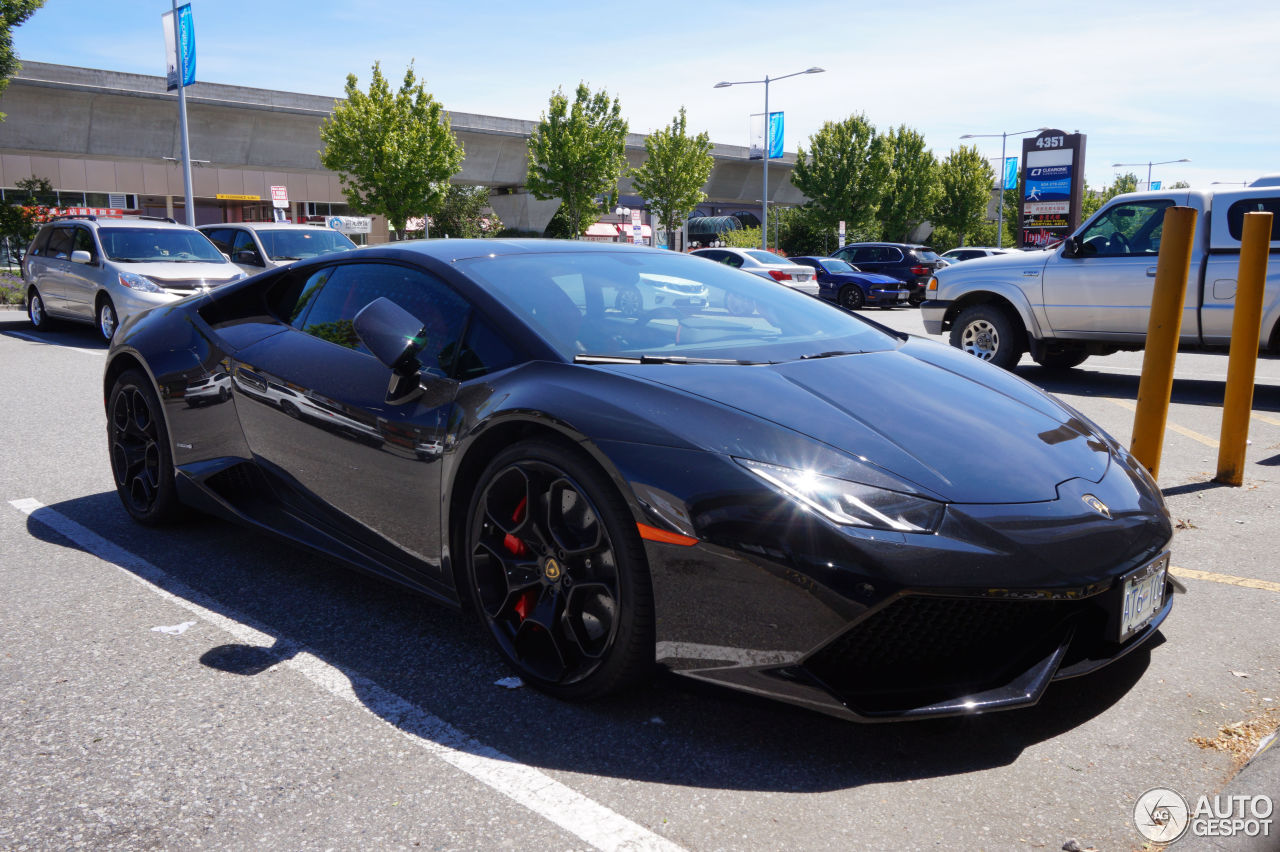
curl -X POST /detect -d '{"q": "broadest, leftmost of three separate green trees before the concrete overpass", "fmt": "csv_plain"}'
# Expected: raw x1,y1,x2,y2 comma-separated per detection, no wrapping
320,63,462,238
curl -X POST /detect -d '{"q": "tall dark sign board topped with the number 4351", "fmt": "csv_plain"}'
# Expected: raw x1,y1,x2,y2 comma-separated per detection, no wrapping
1018,129,1084,248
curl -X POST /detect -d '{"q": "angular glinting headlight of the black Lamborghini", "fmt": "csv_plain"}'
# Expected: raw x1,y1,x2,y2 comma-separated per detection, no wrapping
733,458,945,532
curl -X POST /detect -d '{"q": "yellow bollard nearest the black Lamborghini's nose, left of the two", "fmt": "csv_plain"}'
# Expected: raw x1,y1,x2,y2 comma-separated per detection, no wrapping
1130,207,1196,478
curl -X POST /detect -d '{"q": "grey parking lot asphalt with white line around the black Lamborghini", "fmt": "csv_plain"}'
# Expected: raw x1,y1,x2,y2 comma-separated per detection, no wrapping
0,310,1280,849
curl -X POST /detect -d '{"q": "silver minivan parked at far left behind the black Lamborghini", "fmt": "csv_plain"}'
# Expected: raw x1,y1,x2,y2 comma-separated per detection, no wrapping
22,216,244,340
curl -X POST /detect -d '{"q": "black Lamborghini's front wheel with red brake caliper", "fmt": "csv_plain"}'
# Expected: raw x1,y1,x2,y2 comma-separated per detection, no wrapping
467,440,654,700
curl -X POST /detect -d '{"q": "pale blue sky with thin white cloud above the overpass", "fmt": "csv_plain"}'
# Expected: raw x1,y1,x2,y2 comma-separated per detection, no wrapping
14,0,1280,187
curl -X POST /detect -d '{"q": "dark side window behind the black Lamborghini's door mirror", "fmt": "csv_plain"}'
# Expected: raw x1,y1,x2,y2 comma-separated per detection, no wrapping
293,258,468,371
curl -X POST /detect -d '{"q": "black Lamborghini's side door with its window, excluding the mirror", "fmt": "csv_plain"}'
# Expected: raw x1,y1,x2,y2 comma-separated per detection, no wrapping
232,261,468,580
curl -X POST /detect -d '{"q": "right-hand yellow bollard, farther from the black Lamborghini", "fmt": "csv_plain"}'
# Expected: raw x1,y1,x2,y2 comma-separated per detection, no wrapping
1213,212,1271,486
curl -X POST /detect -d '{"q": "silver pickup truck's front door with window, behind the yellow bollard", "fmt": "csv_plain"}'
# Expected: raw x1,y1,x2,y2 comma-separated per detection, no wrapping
1042,198,1177,340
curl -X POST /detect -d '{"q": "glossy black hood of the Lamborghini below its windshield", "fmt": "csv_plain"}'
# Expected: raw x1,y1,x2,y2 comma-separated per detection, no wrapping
604,340,1110,503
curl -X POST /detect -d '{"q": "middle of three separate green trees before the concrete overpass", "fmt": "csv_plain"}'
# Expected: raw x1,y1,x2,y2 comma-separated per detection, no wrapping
526,83,627,237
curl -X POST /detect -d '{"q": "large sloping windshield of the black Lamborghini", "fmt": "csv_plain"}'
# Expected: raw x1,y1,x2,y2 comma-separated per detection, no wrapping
458,251,896,363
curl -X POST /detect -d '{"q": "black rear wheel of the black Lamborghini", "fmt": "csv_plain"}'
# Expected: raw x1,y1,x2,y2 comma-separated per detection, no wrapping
106,370,182,525
